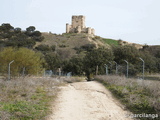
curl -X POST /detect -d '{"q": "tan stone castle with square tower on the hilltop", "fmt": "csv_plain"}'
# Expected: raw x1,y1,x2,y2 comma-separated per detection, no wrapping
66,15,95,35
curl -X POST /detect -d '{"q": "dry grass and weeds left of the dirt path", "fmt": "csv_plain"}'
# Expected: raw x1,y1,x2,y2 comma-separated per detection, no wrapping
0,77,61,120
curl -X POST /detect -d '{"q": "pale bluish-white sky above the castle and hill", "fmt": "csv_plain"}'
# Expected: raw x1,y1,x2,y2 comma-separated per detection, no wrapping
0,0,160,45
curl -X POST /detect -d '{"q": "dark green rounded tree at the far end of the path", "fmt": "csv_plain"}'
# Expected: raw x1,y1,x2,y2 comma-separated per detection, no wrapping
84,48,114,80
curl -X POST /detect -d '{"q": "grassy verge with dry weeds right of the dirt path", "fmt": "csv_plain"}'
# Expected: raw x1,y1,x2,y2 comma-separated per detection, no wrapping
96,76,160,120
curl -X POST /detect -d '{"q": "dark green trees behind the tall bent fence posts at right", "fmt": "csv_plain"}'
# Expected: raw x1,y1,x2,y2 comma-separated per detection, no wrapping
113,45,158,76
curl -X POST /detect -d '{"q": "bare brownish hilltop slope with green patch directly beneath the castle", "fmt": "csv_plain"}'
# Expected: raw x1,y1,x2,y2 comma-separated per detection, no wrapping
39,32,143,49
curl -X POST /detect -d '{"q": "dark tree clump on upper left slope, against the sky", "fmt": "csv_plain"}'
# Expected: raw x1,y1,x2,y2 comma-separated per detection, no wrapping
0,23,44,48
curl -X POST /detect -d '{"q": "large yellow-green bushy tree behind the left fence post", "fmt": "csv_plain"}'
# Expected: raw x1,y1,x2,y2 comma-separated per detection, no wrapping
0,47,45,76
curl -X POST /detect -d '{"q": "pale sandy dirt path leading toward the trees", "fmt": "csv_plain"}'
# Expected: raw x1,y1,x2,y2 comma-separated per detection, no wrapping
49,81,130,120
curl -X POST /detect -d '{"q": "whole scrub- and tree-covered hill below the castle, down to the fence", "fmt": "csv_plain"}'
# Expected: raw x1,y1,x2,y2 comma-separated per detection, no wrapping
0,24,160,79
